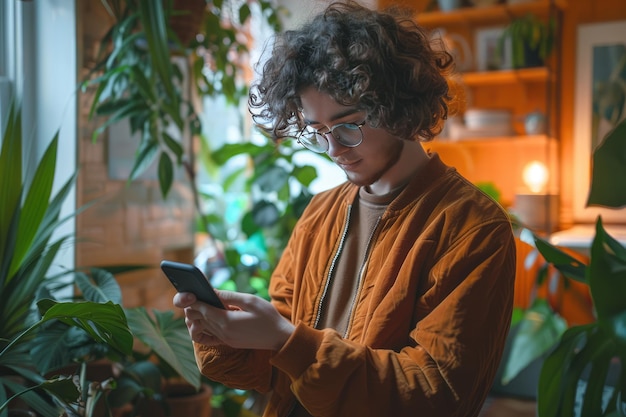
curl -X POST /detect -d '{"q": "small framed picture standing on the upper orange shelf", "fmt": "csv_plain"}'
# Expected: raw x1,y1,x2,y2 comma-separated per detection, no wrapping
474,26,513,71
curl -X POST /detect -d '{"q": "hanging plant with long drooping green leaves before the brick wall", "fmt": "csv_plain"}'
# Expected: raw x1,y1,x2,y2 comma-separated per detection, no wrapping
83,0,279,196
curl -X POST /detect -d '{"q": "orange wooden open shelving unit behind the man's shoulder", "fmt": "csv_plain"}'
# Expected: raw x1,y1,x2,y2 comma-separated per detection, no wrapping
379,0,567,206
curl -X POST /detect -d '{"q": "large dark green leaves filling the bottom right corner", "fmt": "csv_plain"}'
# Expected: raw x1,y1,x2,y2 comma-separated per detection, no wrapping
537,219,626,417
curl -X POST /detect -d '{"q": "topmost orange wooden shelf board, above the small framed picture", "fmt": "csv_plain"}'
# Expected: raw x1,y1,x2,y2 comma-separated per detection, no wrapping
416,0,567,28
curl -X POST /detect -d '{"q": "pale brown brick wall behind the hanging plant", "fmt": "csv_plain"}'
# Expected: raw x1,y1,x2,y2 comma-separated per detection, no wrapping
76,0,194,309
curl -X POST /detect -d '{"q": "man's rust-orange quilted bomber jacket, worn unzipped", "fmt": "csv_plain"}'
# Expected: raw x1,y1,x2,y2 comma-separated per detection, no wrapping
195,154,515,417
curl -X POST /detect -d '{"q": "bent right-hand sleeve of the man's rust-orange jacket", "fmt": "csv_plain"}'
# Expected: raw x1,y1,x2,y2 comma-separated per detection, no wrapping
271,222,515,417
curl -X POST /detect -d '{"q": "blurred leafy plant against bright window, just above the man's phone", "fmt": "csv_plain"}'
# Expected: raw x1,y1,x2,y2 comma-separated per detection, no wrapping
190,134,326,417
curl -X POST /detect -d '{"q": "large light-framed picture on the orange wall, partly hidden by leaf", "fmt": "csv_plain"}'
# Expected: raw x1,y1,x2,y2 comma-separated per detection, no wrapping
572,20,626,224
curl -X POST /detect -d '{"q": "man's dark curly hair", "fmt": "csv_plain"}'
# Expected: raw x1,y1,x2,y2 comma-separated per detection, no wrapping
248,1,453,140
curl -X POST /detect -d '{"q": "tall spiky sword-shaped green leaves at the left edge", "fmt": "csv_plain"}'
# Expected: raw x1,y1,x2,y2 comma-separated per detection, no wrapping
0,105,75,415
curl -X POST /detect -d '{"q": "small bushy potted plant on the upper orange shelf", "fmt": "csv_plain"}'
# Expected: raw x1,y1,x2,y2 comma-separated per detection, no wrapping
497,14,556,69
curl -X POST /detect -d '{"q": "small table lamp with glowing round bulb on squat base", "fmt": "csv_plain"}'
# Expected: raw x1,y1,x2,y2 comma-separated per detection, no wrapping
514,161,559,232
